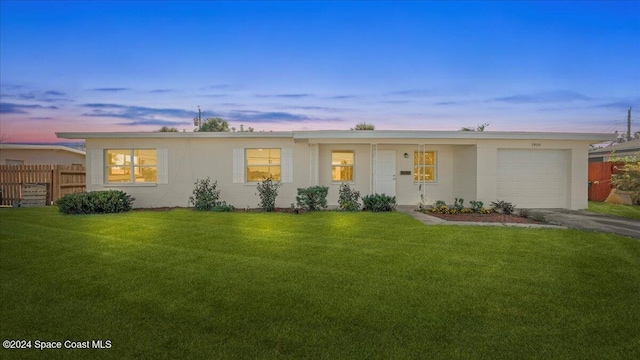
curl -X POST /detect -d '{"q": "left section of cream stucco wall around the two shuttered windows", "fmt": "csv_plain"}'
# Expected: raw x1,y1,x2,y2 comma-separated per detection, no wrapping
87,138,309,208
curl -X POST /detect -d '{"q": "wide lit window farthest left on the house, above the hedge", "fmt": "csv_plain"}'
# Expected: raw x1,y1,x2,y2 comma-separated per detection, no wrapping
106,149,158,184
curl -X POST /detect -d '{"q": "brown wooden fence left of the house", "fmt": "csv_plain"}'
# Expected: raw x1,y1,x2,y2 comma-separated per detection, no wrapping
0,165,86,206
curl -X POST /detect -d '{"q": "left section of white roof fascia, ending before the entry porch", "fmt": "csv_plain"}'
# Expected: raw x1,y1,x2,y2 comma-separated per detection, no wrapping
56,131,293,139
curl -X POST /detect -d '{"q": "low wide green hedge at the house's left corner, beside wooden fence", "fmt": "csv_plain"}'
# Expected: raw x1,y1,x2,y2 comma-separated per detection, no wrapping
56,190,135,215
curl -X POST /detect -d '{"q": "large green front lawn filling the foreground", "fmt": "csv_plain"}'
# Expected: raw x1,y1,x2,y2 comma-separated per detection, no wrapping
0,208,640,359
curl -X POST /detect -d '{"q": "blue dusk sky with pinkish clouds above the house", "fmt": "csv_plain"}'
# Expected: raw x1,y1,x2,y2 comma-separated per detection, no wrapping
0,0,640,142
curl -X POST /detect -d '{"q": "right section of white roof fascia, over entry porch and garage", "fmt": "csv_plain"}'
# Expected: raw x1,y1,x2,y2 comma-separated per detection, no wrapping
293,130,616,142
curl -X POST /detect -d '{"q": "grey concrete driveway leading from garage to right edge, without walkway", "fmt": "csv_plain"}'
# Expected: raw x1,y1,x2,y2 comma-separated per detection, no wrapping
533,209,640,239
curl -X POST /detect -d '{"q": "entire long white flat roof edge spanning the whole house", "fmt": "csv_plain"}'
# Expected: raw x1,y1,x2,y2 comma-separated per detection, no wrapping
56,130,616,142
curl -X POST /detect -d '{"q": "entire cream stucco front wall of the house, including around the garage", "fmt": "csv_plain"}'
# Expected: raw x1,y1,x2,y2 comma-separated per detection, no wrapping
86,136,589,209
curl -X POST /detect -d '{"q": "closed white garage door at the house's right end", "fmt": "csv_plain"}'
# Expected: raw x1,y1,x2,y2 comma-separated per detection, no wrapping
498,149,569,208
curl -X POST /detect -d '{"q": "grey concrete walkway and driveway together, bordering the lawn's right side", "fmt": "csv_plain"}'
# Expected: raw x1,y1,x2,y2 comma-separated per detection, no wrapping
397,206,640,239
